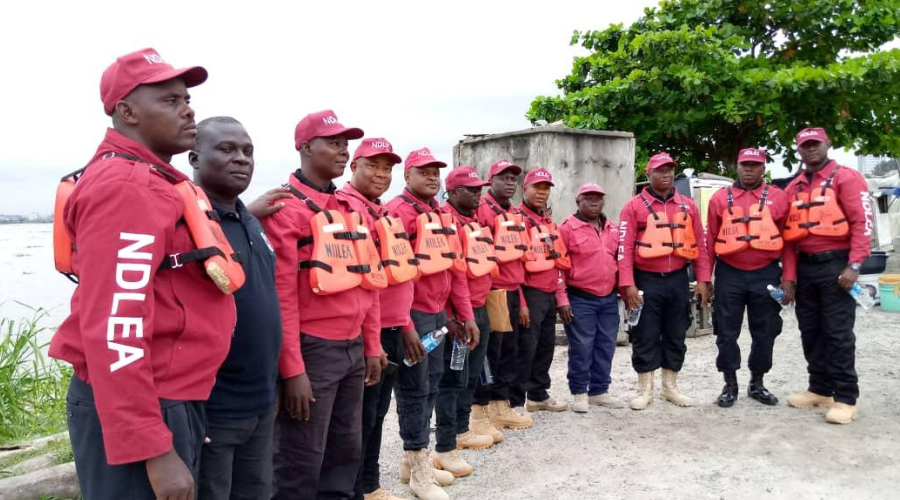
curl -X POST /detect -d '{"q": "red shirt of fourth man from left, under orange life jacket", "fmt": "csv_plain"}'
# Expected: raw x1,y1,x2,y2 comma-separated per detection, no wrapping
335,182,413,328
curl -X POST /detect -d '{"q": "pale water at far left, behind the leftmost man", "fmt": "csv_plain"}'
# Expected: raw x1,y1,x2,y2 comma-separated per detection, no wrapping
0,224,75,341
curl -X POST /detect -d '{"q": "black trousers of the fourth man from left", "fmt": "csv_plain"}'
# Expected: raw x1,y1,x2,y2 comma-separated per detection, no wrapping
354,327,404,500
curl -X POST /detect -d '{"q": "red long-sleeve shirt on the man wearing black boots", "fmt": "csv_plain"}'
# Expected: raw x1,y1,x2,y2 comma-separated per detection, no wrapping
706,182,796,271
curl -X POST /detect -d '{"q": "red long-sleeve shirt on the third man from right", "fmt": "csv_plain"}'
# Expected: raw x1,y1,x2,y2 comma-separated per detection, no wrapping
619,187,710,287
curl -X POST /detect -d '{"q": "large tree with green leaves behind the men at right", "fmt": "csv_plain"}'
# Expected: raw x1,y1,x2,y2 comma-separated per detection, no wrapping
527,0,900,173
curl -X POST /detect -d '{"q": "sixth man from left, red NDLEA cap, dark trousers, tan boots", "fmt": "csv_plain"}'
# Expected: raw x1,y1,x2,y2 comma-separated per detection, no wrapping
434,166,503,477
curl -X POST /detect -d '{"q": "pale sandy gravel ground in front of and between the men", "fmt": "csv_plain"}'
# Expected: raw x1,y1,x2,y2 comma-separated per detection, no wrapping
370,296,900,500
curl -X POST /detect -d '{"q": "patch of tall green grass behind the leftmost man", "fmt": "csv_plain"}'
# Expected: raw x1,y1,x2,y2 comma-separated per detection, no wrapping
0,302,72,445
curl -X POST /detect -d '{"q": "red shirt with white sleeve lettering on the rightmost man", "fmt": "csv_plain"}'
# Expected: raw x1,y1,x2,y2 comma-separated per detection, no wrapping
784,160,873,281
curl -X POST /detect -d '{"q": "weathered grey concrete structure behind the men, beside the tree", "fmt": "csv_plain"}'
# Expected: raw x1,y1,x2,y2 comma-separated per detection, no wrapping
453,126,634,223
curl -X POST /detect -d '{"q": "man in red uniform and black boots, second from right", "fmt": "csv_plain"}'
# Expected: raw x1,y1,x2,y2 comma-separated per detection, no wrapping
706,148,796,408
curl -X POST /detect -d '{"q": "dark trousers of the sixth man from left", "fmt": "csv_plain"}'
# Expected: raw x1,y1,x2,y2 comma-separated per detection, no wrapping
434,307,490,453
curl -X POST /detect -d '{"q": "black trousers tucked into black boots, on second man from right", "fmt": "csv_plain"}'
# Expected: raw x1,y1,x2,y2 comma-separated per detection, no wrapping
713,260,782,374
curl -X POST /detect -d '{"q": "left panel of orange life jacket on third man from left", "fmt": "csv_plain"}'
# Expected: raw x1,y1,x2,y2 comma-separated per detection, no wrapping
288,186,371,295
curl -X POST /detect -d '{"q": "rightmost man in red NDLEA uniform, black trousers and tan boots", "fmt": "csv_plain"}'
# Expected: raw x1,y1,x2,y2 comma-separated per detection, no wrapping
784,128,872,424
